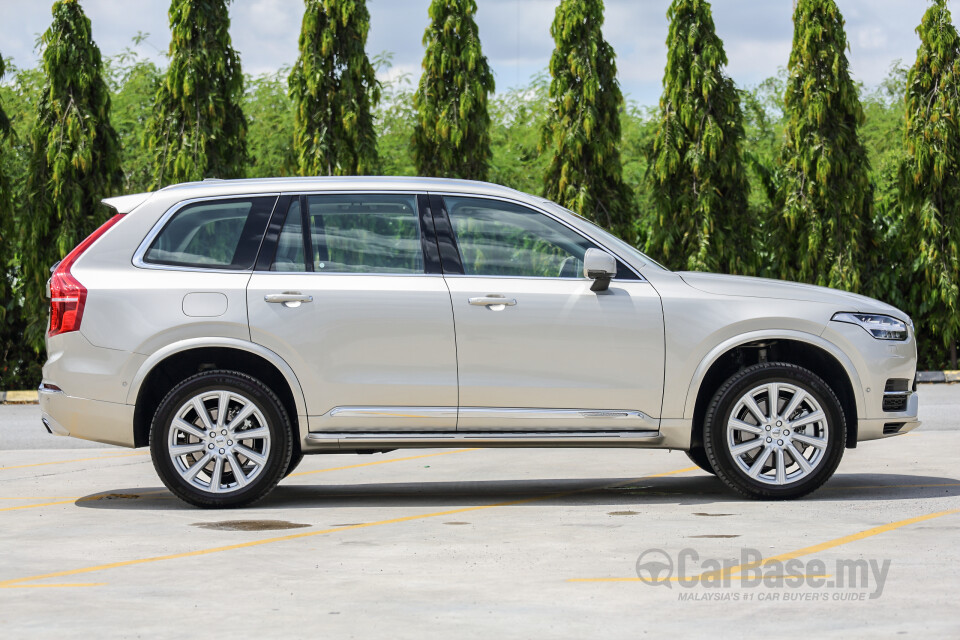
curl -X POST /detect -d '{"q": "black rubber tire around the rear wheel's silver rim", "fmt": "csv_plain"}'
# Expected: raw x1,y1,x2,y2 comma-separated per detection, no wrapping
150,370,293,509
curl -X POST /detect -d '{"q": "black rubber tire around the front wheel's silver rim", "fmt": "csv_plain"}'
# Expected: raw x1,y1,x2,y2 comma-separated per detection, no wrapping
703,362,846,500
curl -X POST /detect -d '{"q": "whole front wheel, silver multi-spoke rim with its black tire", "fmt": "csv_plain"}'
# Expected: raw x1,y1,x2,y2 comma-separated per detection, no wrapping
704,363,846,498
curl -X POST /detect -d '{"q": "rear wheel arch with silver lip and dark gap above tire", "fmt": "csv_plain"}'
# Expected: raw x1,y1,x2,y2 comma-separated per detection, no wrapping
127,338,308,447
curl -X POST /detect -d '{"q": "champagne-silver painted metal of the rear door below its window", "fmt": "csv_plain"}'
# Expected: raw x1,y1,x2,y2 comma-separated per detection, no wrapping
248,272,457,431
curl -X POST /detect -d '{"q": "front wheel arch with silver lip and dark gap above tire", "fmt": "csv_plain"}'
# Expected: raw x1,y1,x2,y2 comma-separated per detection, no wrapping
684,331,864,448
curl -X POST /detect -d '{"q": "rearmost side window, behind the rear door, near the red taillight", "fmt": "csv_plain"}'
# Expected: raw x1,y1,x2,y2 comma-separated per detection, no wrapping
143,196,277,264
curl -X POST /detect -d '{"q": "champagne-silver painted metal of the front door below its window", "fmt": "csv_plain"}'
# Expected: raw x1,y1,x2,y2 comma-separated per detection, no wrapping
446,275,664,431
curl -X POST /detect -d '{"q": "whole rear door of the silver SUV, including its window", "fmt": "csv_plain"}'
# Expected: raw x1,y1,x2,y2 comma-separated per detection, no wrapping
247,193,457,432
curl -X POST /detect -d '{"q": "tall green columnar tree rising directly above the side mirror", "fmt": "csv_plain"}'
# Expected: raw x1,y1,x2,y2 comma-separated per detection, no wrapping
540,0,635,241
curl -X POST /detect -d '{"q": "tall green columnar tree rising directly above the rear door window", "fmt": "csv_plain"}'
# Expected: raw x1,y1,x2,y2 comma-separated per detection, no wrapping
290,0,380,176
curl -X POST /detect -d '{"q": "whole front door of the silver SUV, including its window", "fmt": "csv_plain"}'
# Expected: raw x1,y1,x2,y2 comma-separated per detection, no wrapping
442,196,664,431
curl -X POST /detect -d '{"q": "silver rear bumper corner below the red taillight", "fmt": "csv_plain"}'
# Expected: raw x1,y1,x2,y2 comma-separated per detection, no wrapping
39,387,134,448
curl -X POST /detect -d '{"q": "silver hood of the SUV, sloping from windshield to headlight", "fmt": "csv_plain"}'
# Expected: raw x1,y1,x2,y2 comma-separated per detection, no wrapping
677,271,909,320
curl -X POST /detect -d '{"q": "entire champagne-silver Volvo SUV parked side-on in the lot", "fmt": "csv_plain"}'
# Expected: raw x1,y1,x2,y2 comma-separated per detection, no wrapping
40,178,919,507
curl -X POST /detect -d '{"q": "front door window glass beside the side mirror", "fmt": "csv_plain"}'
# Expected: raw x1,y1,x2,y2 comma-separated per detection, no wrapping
444,196,596,278
